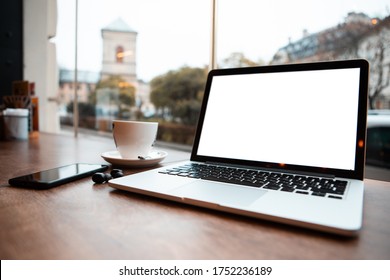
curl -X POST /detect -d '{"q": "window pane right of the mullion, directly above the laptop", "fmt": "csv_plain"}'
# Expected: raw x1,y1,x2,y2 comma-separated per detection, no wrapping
217,0,390,109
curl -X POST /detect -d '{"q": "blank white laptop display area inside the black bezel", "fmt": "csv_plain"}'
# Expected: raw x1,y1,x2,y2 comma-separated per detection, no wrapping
197,68,360,170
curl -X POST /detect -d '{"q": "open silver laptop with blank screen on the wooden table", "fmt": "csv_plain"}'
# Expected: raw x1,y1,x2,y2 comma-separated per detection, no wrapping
109,59,369,236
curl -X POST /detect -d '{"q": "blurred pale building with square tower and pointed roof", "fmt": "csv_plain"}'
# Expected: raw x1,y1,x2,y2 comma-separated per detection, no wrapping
58,18,154,127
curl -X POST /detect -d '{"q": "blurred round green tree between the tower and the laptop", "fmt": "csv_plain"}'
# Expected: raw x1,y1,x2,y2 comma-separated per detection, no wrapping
150,67,207,125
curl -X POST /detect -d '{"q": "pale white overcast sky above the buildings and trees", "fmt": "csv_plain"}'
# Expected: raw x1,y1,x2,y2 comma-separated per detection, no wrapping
52,0,390,81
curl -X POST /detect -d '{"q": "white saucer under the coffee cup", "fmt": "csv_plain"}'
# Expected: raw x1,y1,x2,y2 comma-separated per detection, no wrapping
101,151,168,167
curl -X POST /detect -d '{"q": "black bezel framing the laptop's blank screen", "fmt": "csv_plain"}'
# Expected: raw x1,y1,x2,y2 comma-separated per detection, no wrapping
191,59,369,180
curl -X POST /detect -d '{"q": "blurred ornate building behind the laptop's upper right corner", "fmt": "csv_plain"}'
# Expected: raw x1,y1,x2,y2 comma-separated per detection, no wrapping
271,13,390,109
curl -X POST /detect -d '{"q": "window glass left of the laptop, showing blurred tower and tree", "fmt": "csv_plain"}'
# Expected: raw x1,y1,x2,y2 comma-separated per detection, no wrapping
56,0,211,144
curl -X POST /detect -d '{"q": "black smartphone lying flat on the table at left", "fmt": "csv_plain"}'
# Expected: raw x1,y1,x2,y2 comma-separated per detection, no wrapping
8,163,108,189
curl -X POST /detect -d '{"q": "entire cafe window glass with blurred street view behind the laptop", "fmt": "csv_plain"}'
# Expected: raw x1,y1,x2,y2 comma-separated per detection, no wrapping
56,0,390,149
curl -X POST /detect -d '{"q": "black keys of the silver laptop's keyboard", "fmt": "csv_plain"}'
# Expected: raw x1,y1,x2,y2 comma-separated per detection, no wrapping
159,163,348,199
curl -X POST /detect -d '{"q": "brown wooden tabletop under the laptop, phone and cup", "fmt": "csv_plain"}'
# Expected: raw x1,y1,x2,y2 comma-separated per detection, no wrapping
0,133,390,259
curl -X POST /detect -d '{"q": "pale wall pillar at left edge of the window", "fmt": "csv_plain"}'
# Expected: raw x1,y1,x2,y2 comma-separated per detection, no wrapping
23,0,60,133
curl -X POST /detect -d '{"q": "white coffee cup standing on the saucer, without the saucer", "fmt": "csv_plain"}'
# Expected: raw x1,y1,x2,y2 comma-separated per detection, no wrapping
112,120,158,159
